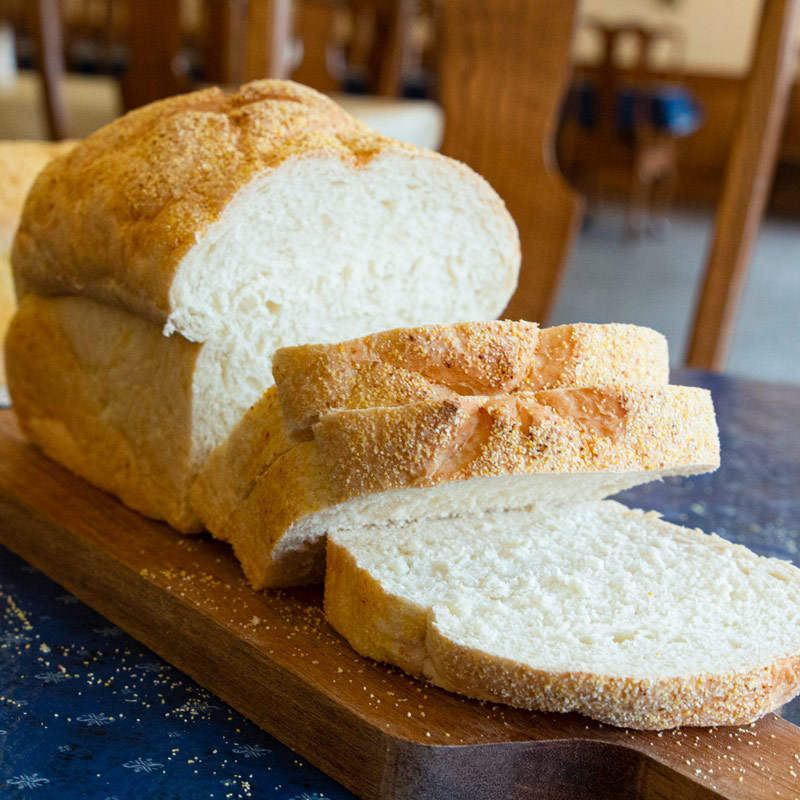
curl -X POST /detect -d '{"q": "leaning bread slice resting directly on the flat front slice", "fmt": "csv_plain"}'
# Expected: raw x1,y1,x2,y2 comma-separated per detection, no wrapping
198,384,719,589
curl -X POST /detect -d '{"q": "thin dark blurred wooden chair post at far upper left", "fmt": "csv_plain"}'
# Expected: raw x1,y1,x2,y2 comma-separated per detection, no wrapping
34,0,67,141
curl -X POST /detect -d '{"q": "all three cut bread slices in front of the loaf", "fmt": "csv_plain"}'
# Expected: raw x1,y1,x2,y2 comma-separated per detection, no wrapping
194,322,800,729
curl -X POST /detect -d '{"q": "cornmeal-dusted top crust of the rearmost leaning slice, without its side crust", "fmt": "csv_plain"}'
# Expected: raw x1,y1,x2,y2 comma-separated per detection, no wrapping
272,321,669,436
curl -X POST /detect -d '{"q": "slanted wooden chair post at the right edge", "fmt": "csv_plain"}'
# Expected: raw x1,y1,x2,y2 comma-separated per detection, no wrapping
686,0,800,370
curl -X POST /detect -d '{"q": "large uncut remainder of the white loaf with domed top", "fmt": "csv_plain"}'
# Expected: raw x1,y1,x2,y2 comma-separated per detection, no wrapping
7,81,519,531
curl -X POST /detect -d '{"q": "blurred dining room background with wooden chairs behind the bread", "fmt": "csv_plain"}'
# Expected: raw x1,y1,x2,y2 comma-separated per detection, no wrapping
0,0,800,383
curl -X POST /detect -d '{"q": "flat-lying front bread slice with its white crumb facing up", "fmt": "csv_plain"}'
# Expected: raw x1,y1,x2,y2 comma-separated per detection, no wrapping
325,501,800,729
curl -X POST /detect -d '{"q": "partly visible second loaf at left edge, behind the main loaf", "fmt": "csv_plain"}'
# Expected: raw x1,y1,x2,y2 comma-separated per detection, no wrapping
0,141,75,397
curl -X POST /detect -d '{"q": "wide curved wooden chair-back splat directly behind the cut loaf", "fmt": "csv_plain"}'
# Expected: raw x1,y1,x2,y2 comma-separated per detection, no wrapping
437,0,581,322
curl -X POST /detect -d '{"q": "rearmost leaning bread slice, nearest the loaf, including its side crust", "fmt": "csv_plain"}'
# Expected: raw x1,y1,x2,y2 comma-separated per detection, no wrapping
192,320,669,560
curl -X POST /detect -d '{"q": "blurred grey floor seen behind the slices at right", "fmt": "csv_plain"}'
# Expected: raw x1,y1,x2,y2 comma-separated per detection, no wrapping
553,207,800,383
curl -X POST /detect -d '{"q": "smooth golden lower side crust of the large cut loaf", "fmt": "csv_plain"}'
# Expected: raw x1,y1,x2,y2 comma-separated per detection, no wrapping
6,295,201,532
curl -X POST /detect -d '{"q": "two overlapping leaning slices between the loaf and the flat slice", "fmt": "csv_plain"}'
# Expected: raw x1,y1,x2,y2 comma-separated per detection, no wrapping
192,322,719,589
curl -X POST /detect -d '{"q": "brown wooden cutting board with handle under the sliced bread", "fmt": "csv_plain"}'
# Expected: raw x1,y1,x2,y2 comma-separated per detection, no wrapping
0,411,800,800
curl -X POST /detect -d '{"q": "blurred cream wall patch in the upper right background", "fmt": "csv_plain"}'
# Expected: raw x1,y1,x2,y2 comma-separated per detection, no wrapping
575,0,761,74
